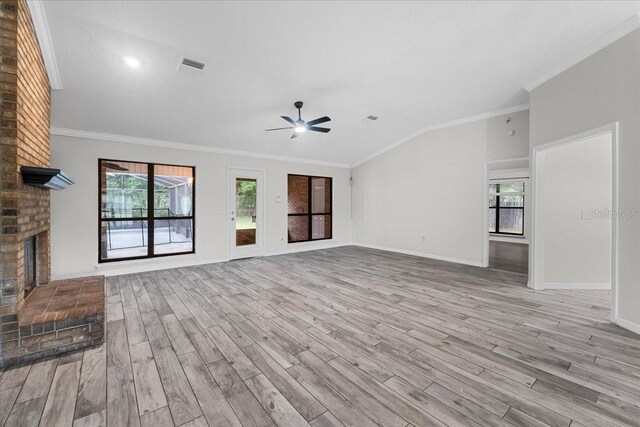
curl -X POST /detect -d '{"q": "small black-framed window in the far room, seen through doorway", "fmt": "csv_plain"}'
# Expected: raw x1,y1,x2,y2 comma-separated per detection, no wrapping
489,181,525,236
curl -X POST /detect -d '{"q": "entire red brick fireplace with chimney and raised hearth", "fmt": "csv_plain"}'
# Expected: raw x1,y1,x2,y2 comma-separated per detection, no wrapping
0,0,104,366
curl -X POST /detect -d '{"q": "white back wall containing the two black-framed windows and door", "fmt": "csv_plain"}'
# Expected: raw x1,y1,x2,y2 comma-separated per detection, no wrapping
51,136,351,278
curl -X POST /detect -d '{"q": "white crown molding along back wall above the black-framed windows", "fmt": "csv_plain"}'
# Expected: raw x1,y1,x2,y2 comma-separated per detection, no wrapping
51,127,351,169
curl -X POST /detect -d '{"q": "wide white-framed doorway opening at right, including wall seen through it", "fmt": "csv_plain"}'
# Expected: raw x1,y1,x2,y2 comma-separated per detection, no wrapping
529,124,621,321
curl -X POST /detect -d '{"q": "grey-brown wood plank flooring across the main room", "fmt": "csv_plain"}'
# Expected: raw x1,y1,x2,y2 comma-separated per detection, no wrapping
0,247,640,427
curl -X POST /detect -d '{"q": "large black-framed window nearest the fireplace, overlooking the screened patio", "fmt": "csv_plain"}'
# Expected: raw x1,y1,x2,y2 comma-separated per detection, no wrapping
98,159,195,262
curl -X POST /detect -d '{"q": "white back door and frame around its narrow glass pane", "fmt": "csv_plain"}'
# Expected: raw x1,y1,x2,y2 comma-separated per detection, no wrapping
227,166,267,261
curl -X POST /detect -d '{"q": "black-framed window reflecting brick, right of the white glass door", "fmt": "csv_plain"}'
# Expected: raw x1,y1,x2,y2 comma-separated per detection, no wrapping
287,175,333,243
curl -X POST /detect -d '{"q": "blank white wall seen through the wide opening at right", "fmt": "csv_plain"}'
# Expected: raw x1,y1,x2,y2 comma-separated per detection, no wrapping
535,135,611,289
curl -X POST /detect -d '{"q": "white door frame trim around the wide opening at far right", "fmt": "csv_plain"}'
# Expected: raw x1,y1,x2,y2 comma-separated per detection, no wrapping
529,122,619,323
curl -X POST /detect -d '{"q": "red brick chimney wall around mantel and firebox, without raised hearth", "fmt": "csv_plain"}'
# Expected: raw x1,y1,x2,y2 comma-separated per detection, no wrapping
0,0,51,360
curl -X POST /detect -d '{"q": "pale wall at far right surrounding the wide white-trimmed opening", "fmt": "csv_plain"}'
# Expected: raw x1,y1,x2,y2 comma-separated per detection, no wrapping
530,30,640,332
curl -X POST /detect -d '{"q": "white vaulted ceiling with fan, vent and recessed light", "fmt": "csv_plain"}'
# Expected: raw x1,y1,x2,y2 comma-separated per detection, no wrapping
44,1,640,164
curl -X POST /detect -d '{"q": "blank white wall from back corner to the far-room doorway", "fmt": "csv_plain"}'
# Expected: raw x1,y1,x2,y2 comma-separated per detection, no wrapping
352,111,529,265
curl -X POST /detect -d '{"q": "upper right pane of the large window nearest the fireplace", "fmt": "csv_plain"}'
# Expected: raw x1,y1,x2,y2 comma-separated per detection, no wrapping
153,165,193,218
